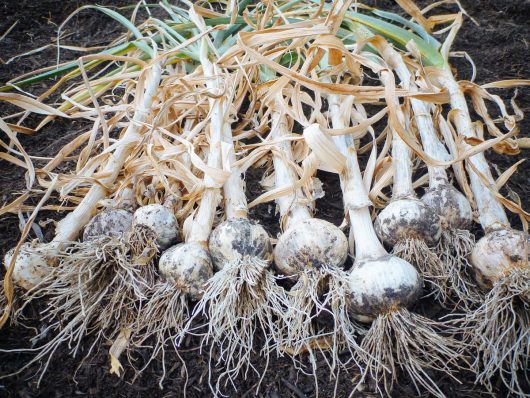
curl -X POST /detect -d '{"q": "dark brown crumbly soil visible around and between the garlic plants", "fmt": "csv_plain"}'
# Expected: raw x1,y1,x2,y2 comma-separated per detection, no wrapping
0,0,530,398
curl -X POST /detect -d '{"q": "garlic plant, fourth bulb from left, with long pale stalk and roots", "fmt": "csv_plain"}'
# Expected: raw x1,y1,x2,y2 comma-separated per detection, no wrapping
132,37,227,383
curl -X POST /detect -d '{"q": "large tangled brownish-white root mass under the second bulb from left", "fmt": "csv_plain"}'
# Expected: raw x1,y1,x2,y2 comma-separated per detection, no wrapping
1,237,155,384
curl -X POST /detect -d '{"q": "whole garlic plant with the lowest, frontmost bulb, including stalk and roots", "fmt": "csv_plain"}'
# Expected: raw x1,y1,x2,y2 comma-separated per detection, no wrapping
310,109,458,397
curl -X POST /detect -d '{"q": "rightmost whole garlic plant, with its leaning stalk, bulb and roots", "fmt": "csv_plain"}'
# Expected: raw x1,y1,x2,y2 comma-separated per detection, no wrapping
437,61,530,396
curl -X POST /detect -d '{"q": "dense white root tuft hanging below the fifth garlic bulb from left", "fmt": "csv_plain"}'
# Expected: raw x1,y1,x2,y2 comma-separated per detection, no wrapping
194,255,287,387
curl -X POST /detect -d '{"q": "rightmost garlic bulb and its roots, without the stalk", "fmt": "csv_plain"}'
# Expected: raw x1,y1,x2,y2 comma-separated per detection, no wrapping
462,225,530,397
